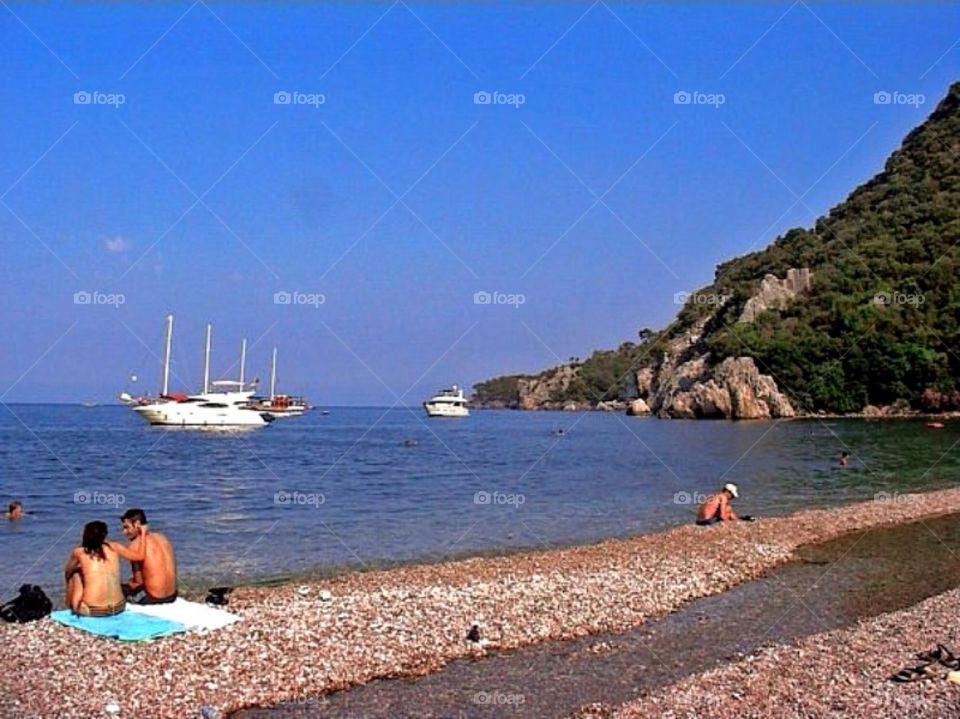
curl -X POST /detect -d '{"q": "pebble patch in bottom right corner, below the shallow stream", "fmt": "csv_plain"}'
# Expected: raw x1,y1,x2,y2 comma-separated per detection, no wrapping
608,589,960,719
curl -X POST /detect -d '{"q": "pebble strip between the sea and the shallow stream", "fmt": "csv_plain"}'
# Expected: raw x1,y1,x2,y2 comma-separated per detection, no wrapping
0,489,960,716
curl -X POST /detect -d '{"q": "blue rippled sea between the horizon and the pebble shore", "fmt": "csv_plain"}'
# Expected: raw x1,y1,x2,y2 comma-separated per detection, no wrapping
0,405,960,595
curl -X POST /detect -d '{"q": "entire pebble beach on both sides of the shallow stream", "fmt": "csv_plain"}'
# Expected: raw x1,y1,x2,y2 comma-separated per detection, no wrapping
0,489,960,717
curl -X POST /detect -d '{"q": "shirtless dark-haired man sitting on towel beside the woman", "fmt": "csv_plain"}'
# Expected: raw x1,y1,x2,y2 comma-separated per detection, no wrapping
120,509,177,604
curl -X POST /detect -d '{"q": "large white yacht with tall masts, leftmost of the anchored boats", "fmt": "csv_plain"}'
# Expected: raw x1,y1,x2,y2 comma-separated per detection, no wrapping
120,315,273,427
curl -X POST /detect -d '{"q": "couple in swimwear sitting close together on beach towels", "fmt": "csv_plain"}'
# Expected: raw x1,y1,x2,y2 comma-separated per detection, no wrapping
64,509,177,617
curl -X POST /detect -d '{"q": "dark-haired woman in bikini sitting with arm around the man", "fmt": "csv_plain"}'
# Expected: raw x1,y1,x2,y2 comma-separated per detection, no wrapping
63,521,143,617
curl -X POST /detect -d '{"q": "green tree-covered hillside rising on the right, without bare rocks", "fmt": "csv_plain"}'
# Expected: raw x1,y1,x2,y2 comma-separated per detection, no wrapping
475,83,960,412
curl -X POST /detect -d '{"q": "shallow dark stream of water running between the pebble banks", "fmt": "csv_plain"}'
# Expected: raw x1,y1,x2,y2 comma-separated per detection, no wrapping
233,515,960,719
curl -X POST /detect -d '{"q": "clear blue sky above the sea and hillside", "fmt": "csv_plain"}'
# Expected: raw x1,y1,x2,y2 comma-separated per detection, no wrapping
0,2,960,404
